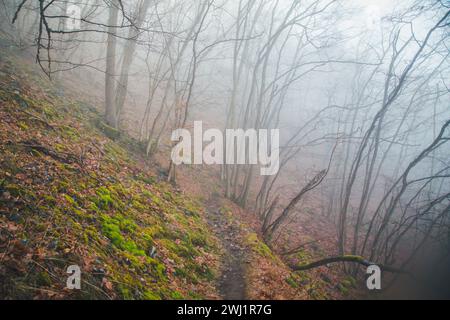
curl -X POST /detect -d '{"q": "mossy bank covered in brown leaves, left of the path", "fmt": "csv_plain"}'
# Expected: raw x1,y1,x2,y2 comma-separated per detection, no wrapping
0,44,220,299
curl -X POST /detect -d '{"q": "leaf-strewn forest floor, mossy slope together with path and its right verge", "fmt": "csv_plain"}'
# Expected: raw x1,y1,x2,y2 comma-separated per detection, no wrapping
0,41,357,299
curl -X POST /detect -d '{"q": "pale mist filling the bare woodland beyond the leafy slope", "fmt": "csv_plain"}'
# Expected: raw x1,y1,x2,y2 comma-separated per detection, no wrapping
1,0,450,290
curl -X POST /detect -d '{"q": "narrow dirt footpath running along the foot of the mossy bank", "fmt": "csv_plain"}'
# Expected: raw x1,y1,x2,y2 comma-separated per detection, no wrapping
206,198,246,300
